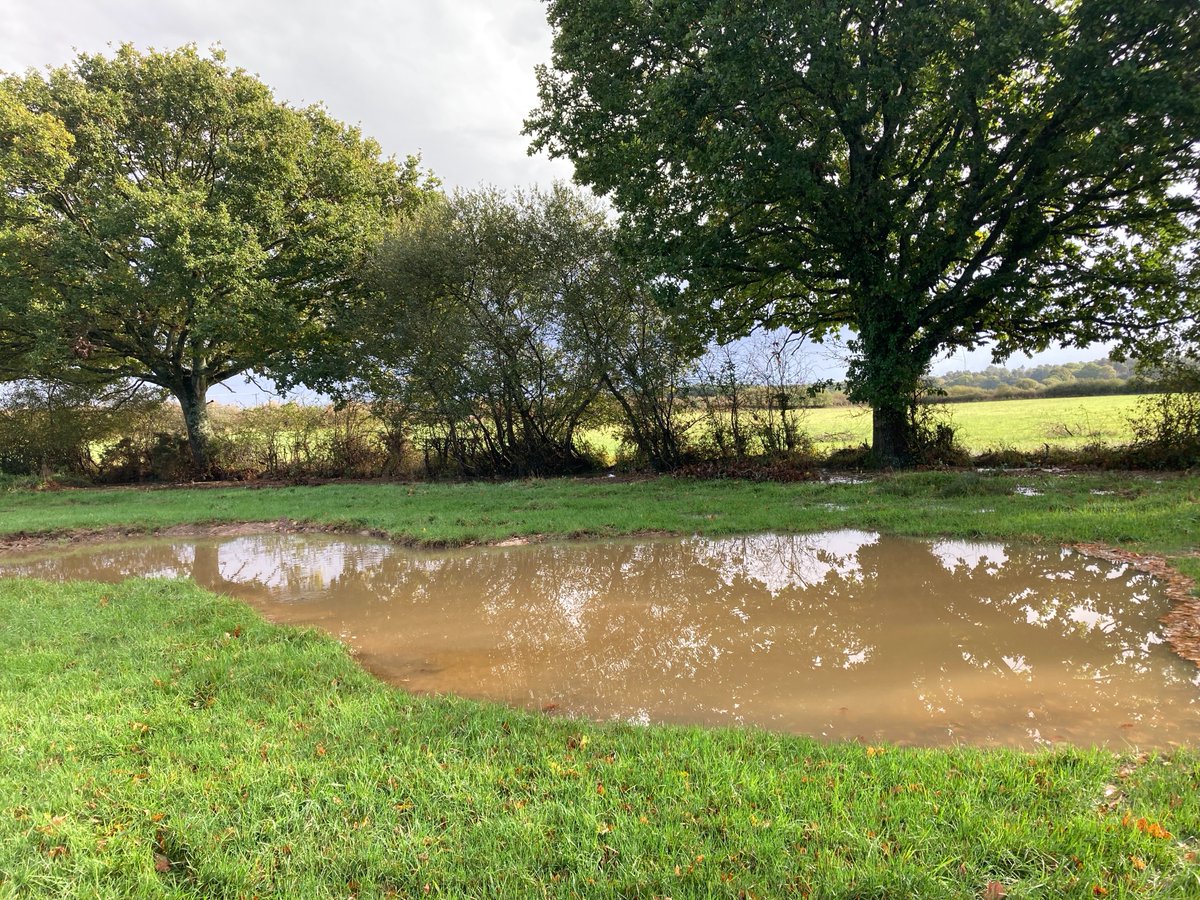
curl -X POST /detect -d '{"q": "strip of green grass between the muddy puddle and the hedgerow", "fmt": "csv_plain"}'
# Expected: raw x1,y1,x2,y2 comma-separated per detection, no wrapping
0,472,1200,554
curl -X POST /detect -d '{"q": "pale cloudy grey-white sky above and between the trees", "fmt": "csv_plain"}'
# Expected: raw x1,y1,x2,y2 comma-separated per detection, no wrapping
0,0,1104,403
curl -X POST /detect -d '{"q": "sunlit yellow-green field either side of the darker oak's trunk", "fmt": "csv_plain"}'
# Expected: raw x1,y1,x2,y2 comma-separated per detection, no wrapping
804,395,1146,452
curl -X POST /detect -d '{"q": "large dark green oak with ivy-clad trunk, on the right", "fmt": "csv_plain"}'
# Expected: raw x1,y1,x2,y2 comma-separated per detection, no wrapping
527,0,1200,462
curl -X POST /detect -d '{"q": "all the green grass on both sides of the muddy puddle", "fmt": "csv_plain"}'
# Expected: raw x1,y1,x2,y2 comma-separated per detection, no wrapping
0,473,1200,898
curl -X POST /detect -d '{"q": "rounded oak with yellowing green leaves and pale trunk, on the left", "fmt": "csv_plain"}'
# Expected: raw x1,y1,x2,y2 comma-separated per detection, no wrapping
0,46,427,474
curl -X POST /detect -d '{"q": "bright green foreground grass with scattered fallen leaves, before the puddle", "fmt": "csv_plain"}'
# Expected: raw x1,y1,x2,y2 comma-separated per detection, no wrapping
0,581,1200,898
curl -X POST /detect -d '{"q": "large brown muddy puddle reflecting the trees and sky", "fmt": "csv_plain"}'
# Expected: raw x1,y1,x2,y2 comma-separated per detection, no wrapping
0,530,1200,748
